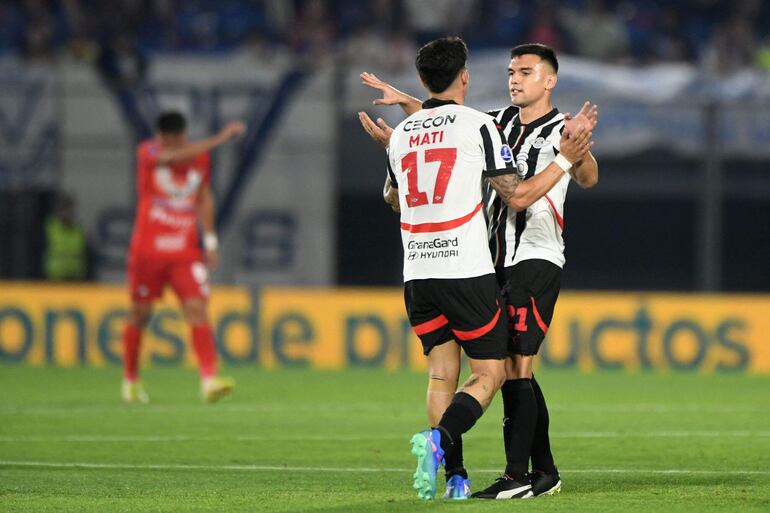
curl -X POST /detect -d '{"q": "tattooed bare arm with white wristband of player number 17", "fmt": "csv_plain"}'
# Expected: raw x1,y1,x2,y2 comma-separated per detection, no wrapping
487,126,593,212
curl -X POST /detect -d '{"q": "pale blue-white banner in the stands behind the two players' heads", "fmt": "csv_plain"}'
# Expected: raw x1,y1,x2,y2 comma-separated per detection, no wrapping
347,49,770,158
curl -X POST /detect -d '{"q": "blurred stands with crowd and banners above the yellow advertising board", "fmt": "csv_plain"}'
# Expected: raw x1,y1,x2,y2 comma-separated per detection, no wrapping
0,0,770,291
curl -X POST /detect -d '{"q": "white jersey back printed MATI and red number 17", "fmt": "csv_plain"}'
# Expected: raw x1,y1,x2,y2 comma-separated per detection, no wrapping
388,99,515,281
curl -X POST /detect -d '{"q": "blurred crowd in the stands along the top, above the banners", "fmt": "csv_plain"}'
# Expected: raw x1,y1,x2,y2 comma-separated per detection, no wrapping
0,0,770,76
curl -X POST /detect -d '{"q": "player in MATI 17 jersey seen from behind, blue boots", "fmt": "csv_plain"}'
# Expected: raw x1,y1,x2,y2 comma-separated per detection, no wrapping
362,38,591,499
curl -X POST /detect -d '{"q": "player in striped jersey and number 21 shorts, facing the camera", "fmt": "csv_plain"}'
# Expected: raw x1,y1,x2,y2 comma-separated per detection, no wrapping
359,44,598,498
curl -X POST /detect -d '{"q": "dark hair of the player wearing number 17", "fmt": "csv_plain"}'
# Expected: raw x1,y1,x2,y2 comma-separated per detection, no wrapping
414,37,468,93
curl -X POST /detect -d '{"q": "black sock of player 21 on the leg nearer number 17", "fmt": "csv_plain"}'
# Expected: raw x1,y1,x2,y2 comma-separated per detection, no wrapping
503,378,537,481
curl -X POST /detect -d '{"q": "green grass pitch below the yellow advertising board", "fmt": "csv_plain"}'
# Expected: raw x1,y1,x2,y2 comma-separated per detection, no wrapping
0,366,770,513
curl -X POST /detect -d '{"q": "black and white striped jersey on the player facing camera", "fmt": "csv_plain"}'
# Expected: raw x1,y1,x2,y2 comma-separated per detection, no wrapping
484,105,570,268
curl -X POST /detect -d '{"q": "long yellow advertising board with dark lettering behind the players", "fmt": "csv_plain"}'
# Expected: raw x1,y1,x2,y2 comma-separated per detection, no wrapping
0,283,770,373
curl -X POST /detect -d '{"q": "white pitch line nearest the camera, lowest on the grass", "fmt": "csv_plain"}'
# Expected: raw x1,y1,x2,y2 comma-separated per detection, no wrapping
0,460,770,475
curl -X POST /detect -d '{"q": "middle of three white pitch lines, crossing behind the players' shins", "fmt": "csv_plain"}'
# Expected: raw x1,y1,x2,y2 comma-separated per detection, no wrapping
0,431,770,443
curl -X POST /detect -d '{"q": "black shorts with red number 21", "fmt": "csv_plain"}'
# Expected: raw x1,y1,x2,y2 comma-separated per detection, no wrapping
503,260,561,355
